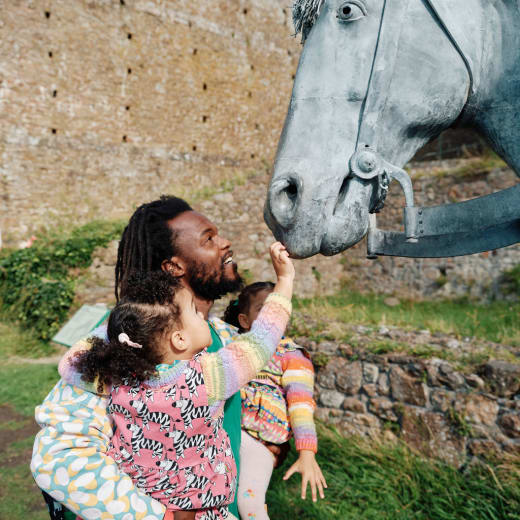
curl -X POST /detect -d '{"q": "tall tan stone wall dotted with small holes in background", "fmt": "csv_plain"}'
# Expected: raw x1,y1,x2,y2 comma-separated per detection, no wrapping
0,0,300,245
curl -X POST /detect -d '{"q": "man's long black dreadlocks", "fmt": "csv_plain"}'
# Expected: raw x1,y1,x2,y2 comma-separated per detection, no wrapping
115,195,192,301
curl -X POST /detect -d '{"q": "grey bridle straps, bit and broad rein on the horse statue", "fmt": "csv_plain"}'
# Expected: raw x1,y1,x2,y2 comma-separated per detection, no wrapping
342,0,520,258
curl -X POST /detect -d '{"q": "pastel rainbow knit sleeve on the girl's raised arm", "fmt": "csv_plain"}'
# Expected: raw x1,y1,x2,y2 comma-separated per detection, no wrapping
201,293,291,403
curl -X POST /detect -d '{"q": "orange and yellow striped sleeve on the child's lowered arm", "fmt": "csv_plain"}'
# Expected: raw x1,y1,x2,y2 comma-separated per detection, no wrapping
281,348,318,453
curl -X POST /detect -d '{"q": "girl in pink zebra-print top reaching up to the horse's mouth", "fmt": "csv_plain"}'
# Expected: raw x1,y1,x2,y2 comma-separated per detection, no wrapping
59,242,294,520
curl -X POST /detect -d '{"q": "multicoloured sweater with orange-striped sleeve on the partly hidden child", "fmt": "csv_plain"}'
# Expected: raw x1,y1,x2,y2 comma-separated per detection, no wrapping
241,338,318,453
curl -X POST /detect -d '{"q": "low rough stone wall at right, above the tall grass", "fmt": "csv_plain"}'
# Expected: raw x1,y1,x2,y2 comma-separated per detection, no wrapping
296,338,520,467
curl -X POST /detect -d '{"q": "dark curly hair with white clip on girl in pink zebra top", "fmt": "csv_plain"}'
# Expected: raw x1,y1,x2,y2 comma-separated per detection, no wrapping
72,271,181,391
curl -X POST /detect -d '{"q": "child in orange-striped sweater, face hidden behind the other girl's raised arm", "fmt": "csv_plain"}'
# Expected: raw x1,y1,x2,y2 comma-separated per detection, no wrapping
223,282,327,520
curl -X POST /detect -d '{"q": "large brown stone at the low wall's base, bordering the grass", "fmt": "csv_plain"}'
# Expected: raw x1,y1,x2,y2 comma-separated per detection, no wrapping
401,405,465,467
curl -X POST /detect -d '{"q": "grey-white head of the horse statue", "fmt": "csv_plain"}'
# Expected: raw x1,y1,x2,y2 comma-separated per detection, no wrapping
264,0,518,258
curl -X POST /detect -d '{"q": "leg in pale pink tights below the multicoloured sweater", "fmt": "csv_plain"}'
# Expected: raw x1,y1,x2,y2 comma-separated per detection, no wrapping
237,432,274,520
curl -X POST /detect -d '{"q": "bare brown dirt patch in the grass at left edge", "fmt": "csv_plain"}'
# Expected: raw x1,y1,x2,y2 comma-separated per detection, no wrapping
0,405,39,468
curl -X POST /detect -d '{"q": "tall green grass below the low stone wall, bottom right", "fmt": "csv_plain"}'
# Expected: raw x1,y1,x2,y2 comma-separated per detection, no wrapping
267,427,520,520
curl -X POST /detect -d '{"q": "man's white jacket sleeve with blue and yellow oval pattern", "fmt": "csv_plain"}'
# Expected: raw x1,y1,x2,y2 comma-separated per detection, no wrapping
31,380,165,520
